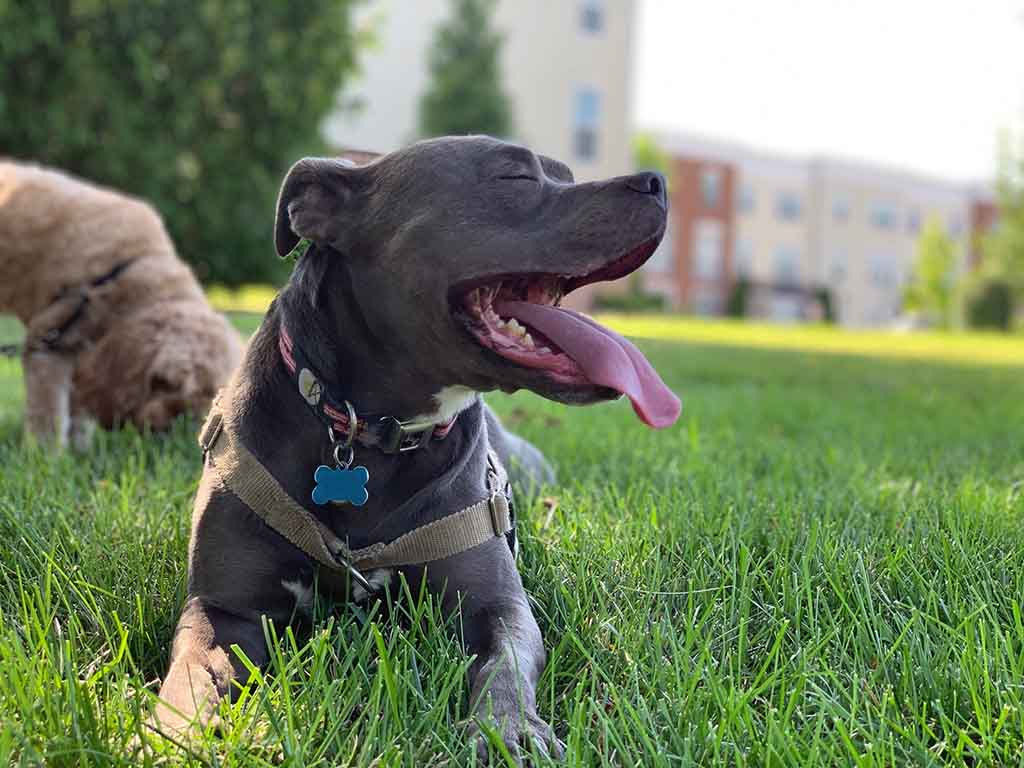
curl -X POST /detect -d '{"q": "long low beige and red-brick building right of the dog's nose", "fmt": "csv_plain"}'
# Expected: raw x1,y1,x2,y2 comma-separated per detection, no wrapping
645,135,984,327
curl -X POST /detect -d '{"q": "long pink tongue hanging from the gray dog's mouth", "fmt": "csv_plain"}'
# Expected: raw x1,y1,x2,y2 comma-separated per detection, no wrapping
495,301,681,429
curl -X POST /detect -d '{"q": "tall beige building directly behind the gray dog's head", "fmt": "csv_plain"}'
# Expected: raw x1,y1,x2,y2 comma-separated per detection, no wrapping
324,0,634,185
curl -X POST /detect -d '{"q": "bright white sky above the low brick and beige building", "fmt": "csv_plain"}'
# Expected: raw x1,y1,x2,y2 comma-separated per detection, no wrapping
634,0,1024,181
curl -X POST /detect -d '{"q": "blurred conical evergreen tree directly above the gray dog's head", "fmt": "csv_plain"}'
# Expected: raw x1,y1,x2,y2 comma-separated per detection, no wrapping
420,0,512,137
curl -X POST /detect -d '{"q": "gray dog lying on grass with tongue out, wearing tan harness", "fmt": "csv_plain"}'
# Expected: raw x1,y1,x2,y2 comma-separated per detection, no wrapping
154,137,679,755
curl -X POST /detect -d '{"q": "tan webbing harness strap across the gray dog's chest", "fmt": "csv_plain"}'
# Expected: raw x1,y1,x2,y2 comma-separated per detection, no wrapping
199,398,514,591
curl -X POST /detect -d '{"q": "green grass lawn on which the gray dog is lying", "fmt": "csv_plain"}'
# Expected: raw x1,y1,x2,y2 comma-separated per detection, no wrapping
0,313,1024,766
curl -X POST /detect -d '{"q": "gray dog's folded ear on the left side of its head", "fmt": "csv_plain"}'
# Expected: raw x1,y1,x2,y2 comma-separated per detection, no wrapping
273,158,358,257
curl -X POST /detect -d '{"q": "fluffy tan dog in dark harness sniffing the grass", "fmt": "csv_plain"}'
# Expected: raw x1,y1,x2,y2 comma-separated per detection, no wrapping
0,161,243,446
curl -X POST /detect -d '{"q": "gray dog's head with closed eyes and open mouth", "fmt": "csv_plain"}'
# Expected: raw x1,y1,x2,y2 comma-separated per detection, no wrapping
275,136,679,426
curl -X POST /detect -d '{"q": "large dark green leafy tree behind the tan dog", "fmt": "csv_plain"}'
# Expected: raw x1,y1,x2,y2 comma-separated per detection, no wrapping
0,0,355,284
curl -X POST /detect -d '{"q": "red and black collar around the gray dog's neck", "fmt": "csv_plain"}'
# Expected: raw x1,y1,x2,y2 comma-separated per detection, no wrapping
278,323,458,454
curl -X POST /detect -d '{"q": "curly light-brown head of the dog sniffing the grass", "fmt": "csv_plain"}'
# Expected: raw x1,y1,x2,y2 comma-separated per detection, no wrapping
74,300,243,430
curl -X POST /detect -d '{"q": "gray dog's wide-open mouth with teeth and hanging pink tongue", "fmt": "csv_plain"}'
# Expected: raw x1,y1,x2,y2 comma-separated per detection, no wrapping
457,241,680,427
